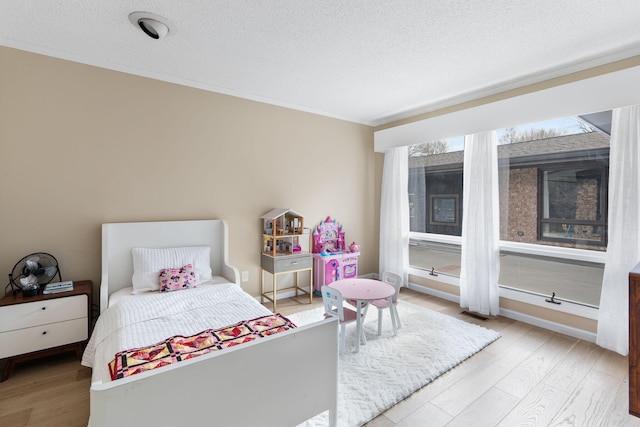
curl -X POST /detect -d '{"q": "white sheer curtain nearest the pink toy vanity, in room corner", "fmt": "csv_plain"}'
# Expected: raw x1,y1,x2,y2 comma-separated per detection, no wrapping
379,147,409,284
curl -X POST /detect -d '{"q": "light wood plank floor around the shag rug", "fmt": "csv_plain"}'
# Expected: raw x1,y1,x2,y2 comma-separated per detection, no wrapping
0,289,640,427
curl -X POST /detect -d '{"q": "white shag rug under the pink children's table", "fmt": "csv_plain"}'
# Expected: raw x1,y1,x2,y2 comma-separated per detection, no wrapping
287,301,500,427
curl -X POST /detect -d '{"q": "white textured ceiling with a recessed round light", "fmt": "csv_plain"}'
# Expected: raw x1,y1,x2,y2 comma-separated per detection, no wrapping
0,0,640,125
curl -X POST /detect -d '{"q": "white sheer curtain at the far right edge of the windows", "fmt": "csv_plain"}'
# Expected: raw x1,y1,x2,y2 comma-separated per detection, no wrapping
596,105,640,356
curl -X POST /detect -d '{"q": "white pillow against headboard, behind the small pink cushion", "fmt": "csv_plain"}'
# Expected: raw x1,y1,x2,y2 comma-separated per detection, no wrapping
131,246,212,294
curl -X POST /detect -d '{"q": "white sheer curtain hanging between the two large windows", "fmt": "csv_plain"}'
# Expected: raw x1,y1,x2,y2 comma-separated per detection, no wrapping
460,131,500,315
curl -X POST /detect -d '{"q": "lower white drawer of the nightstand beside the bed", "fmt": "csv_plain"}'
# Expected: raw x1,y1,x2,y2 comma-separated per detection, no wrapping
0,320,88,358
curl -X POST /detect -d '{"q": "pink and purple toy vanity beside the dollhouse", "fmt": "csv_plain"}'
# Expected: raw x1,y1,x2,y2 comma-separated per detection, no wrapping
312,217,360,294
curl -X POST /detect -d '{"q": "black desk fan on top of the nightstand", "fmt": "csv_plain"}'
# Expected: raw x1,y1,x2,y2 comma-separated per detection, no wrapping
9,252,62,296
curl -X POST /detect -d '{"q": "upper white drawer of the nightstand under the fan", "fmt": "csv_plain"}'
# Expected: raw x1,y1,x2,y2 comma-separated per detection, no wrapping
0,295,88,334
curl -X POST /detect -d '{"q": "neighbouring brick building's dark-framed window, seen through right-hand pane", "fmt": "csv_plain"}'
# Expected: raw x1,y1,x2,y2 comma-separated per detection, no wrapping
538,165,607,245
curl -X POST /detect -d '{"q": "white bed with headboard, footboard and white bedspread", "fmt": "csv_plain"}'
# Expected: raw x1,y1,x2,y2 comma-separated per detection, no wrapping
83,220,338,427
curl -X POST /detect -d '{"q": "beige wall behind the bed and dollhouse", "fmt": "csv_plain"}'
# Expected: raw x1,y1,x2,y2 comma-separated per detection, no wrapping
0,47,382,302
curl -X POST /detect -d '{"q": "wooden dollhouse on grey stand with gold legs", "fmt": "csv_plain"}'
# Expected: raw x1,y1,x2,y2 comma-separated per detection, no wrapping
260,209,313,312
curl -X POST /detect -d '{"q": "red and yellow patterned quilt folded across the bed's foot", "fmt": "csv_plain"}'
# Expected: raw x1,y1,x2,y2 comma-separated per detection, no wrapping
109,314,296,380
